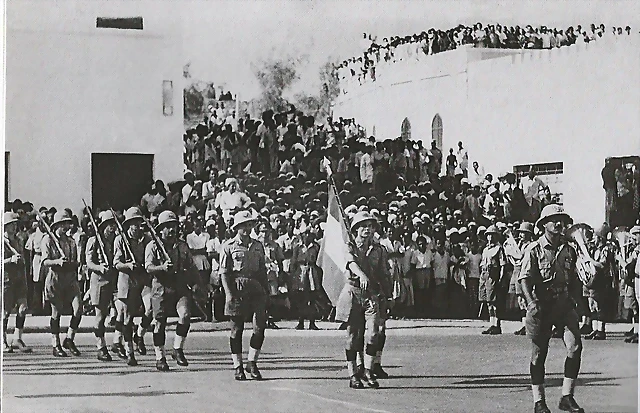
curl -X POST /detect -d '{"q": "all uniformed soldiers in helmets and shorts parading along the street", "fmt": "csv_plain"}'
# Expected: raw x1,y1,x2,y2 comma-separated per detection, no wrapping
3,204,640,413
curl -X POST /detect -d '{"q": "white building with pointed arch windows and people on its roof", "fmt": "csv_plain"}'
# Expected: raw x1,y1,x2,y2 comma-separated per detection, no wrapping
334,35,640,225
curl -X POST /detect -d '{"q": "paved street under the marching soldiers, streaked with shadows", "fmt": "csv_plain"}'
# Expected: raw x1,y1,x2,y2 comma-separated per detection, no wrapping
3,321,638,413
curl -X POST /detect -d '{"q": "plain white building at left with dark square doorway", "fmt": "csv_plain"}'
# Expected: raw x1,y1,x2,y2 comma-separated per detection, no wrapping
5,0,184,212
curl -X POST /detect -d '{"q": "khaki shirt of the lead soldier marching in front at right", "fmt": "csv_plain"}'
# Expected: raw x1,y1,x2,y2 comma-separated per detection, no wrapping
518,235,581,289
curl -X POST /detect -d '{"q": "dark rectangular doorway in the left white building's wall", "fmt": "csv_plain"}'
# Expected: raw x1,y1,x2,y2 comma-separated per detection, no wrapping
91,153,153,210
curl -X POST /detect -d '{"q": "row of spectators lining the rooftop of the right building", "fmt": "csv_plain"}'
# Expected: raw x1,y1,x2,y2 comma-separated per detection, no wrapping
335,23,631,84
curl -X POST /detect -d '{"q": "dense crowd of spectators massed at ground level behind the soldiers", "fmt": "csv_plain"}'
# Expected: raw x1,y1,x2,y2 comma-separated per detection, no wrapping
6,100,632,326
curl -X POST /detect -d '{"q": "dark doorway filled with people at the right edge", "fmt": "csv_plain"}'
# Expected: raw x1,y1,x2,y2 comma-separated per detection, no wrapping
602,156,640,229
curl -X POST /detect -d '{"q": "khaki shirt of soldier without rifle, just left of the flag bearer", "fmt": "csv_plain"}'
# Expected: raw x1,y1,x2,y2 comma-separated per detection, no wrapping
218,236,267,285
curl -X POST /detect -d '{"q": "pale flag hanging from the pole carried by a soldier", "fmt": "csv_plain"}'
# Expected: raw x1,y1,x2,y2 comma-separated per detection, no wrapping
316,185,349,306
